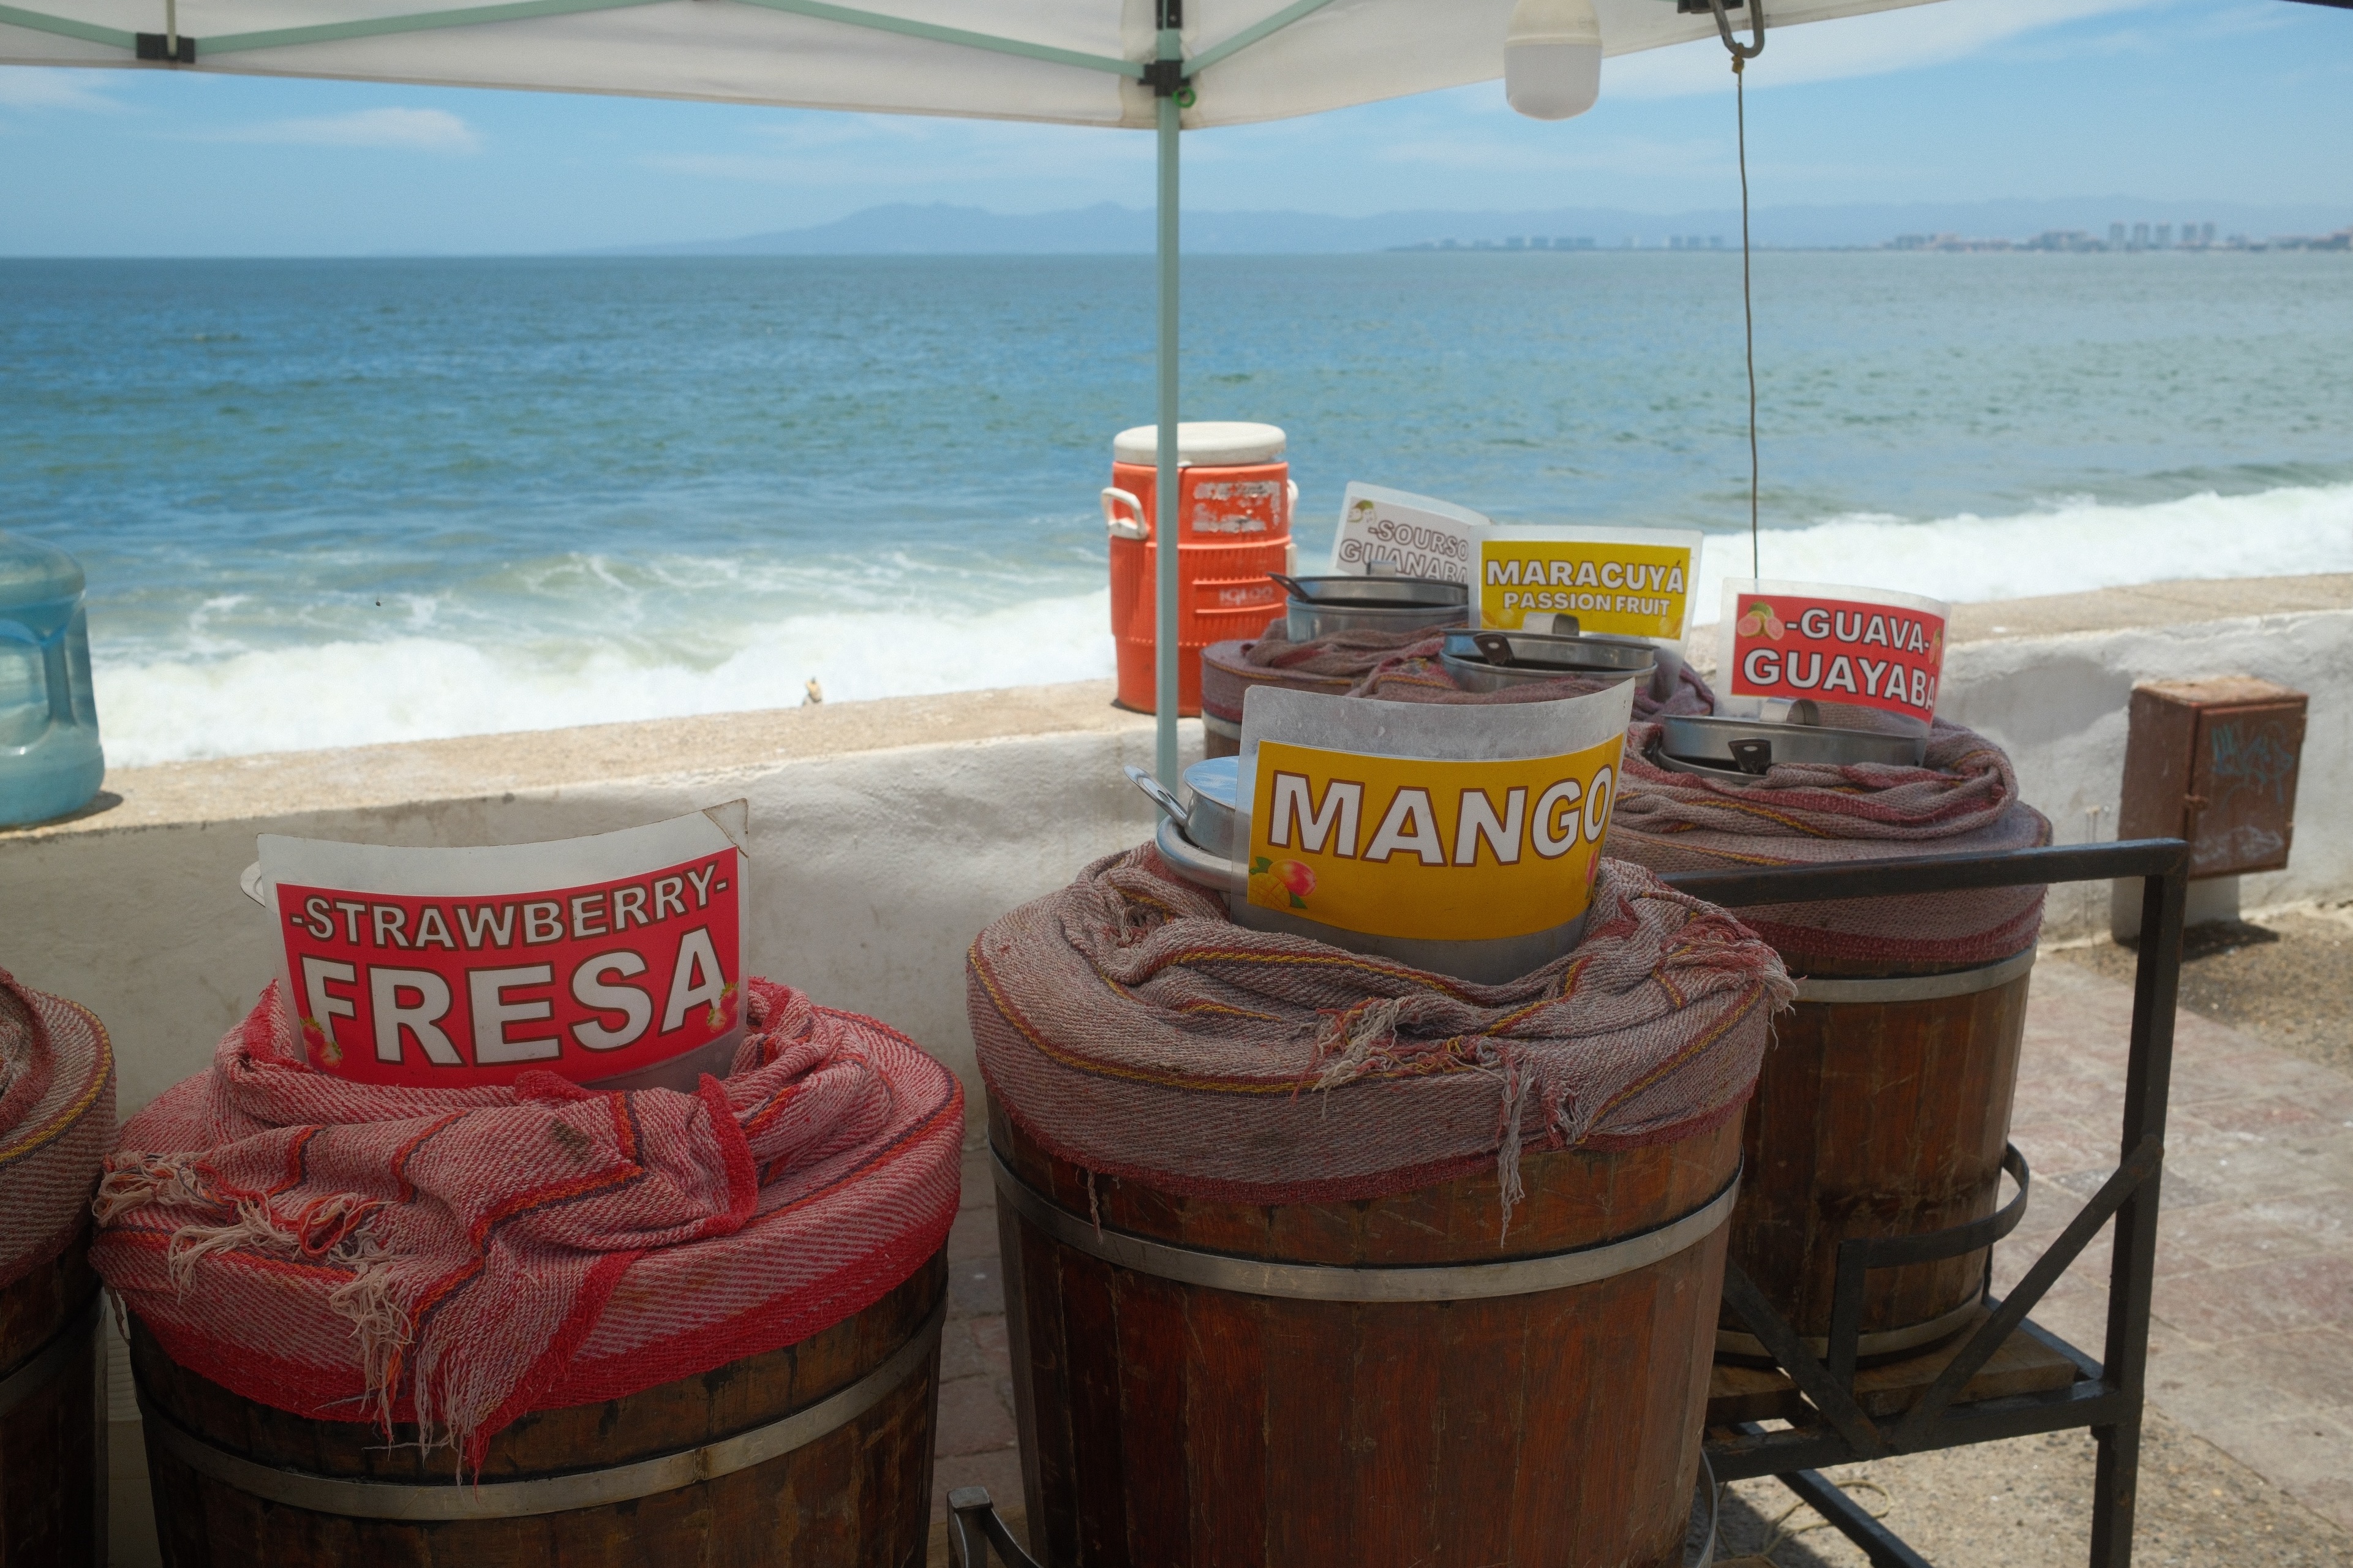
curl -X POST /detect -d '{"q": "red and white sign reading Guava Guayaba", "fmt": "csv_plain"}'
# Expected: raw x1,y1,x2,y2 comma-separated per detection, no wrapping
1725,584,1948,728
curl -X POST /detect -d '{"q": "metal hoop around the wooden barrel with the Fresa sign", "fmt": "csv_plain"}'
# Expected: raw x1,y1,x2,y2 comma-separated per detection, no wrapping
139,1292,948,1521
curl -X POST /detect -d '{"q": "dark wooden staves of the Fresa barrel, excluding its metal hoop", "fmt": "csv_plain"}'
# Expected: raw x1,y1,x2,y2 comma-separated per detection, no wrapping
132,1255,946,1568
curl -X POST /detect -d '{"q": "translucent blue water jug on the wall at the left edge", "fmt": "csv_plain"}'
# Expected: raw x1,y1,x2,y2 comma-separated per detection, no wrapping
0,535,106,826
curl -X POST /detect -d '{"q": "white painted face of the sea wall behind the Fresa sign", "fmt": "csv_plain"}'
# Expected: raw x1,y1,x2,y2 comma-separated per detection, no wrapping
0,723,1200,1116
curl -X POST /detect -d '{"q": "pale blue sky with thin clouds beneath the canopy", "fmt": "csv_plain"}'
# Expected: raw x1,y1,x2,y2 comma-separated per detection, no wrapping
0,0,2353,254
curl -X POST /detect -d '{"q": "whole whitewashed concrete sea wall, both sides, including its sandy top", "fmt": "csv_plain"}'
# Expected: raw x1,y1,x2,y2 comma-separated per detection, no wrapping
0,577,2353,1114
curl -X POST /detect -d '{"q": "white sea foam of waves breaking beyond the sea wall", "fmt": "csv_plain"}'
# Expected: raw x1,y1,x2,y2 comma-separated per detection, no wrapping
97,485,2353,765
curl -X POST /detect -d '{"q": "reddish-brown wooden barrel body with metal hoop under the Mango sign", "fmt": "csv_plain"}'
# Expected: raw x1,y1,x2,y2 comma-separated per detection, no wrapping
990,1107,1739,1568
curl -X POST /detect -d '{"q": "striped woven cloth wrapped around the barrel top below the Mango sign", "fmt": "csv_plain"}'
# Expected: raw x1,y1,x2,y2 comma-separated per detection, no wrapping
967,845,1795,1231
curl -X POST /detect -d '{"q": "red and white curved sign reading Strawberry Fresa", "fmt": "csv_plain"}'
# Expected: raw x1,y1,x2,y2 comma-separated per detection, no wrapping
259,815,744,1088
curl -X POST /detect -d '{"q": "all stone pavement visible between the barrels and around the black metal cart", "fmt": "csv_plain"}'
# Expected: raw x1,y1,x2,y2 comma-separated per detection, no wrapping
932,958,2353,1568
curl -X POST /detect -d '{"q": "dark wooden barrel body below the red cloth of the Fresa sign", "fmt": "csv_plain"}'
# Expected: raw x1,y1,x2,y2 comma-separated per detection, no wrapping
132,1253,948,1568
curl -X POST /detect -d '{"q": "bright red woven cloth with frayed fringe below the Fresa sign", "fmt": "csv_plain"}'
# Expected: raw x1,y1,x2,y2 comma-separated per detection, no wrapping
92,979,962,1464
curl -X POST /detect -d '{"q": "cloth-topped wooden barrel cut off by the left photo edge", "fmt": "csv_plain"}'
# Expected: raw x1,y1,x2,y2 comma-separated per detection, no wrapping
0,973,115,1568
